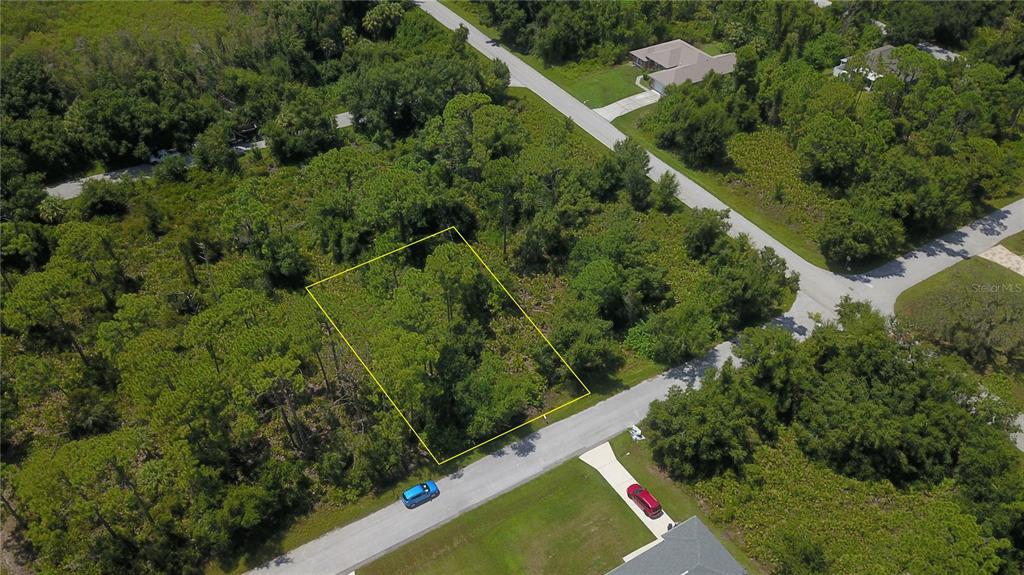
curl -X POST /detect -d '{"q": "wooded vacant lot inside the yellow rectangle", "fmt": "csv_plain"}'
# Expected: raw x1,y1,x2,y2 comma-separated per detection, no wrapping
309,227,589,465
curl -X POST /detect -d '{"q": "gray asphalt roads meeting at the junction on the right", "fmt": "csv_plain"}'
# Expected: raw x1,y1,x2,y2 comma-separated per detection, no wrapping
245,1,1024,575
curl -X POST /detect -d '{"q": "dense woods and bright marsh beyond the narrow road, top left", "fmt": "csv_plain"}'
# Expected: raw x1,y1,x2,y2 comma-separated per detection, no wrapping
2,2,391,194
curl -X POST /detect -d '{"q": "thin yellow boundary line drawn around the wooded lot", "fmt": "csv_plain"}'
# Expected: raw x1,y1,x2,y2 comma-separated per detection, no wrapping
306,226,591,466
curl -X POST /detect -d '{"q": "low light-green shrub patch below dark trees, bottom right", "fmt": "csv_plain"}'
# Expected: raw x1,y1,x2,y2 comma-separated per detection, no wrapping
692,434,1012,573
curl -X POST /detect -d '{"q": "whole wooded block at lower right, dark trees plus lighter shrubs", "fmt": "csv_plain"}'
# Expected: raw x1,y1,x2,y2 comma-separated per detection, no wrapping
644,300,1024,573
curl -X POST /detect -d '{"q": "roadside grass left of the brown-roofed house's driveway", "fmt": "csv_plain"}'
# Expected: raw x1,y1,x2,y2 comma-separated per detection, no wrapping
441,0,641,107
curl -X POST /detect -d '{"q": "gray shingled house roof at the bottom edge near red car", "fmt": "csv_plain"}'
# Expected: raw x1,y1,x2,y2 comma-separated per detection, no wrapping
607,516,746,575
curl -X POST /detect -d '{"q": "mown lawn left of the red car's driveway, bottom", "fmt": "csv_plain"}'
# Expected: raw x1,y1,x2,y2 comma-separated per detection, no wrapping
357,459,651,575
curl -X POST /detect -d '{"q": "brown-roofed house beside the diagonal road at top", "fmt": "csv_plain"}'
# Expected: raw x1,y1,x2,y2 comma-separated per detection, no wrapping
630,40,736,93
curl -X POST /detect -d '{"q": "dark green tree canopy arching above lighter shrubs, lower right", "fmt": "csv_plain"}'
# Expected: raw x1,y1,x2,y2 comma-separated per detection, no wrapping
647,300,1024,573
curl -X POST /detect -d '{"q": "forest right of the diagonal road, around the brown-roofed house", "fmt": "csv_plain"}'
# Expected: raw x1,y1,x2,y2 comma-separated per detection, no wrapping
482,1,1024,266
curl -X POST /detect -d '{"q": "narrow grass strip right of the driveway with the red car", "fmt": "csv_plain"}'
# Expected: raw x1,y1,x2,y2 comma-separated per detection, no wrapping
611,433,768,575
